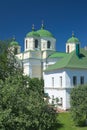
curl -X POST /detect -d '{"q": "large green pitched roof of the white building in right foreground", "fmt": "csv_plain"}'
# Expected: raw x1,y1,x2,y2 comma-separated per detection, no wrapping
46,49,87,71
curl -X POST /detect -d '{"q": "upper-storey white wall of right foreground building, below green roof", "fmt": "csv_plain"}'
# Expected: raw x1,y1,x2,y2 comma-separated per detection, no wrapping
44,69,87,88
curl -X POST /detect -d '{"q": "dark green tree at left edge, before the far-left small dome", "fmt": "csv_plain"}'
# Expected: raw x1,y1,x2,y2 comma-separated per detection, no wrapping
0,39,22,80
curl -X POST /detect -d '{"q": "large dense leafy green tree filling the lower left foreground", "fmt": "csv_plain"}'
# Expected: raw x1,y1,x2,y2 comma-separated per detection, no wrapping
0,74,56,130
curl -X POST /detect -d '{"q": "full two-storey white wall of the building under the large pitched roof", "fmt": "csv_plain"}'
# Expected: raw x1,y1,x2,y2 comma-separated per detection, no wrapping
44,69,87,110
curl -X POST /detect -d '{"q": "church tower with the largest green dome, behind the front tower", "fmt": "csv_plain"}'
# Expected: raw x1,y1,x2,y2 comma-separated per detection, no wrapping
37,23,56,59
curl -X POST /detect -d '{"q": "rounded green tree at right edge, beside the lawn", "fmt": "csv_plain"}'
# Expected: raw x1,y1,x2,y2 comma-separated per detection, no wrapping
71,85,87,126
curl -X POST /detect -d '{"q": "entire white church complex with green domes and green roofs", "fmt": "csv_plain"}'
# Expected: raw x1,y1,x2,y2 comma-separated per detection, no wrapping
11,24,87,110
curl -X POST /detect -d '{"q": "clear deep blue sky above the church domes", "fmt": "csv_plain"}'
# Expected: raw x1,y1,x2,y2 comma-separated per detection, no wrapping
0,0,87,51
